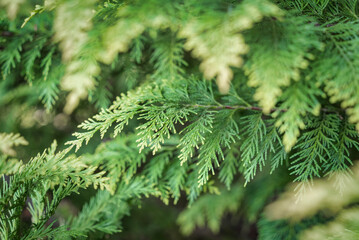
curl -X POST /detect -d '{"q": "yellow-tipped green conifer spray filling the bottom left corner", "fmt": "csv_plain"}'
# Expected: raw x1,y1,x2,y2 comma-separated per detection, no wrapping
0,142,107,239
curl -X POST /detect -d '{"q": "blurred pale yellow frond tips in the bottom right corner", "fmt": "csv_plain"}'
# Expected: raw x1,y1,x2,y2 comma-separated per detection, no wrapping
265,165,359,240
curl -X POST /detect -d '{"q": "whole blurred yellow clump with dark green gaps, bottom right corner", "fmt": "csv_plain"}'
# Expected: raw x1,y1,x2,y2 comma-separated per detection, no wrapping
260,164,359,239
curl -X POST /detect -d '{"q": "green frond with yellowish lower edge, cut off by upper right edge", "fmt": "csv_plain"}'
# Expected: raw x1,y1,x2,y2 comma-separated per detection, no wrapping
315,19,359,129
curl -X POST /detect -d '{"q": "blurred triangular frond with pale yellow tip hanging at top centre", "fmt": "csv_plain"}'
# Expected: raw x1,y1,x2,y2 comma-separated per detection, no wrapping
180,1,281,93
